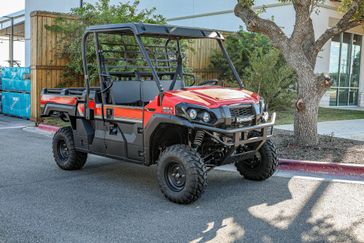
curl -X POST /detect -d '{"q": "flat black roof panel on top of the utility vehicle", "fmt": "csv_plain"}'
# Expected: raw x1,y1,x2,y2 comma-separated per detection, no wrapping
86,23,224,39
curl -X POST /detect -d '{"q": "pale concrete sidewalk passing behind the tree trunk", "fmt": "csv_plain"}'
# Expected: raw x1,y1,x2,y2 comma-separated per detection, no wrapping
275,119,364,141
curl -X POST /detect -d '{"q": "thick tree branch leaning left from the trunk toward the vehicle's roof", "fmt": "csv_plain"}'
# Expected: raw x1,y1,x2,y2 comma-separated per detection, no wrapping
234,2,288,50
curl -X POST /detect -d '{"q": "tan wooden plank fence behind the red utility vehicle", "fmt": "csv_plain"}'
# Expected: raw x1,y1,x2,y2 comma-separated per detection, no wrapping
31,11,223,122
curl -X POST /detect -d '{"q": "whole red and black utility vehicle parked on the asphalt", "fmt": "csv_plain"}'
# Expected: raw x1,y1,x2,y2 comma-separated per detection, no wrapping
41,23,277,204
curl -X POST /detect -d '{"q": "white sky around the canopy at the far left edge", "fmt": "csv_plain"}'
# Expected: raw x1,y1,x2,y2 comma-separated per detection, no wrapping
0,0,25,66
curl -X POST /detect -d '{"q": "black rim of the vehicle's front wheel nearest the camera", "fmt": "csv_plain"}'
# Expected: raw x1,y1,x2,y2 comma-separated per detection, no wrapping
164,162,186,192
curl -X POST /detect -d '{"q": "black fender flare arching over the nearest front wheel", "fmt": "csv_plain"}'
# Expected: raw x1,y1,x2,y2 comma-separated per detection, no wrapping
144,114,195,165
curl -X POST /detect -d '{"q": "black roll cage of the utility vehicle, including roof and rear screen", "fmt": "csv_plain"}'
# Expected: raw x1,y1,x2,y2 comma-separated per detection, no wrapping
82,23,244,116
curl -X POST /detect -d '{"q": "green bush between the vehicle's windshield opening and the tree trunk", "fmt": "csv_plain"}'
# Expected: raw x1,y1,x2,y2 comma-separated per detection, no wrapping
211,30,296,109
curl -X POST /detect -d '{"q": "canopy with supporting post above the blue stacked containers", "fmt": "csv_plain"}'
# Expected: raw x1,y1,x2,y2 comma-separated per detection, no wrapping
0,10,25,66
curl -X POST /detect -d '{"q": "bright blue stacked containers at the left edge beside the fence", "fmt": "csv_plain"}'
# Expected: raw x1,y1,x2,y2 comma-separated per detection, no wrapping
1,67,30,119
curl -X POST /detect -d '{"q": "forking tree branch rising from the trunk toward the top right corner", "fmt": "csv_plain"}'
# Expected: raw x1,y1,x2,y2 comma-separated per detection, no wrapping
312,0,364,56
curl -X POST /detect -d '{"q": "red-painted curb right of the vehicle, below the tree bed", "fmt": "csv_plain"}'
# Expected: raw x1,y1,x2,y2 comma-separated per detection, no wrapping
279,159,364,176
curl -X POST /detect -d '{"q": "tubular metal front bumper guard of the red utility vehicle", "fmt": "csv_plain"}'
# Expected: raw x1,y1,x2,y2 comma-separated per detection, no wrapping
194,112,276,147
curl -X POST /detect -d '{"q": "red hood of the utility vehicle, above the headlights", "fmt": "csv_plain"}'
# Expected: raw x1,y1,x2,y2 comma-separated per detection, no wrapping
166,86,259,108
